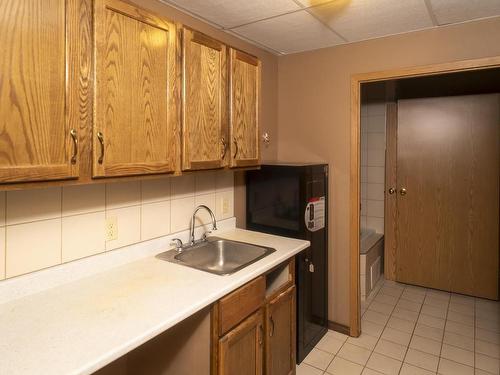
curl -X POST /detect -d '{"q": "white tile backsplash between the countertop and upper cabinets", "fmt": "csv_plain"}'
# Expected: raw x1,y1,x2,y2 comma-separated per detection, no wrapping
0,171,234,280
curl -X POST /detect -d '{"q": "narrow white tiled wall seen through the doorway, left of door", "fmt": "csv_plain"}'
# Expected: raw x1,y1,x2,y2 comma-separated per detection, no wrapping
361,102,386,233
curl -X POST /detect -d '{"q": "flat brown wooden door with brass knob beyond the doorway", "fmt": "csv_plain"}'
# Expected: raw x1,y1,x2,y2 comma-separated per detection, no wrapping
397,95,500,299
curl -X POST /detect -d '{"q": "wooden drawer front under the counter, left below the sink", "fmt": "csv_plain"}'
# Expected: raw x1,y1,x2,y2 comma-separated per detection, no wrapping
219,276,266,336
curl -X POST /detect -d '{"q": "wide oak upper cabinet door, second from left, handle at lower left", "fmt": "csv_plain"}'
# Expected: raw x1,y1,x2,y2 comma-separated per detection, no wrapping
93,0,180,177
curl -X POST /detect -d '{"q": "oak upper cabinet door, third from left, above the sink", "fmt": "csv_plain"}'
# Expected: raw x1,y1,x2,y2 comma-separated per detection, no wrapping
182,27,227,170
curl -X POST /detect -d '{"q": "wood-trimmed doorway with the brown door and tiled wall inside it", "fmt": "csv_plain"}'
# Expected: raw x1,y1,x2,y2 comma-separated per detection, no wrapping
351,60,500,336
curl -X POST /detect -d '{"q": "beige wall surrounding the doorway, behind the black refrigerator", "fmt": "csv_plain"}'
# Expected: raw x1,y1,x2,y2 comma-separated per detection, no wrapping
278,18,500,325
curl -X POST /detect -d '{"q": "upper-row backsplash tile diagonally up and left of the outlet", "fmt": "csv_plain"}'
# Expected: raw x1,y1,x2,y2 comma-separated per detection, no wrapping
62,184,106,216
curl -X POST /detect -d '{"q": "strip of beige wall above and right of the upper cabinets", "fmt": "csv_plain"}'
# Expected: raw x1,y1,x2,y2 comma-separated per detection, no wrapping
128,0,278,164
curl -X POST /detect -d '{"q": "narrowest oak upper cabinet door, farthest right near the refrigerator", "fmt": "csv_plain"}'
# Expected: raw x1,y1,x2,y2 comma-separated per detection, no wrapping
229,49,261,167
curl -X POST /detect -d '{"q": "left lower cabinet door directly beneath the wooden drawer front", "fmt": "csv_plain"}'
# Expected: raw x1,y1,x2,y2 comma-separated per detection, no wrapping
218,310,264,375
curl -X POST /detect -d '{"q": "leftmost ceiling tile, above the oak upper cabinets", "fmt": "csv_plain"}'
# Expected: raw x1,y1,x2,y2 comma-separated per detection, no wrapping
162,0,301,28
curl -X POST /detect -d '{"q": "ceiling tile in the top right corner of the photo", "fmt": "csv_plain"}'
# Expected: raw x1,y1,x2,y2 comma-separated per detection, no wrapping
430,0,500,25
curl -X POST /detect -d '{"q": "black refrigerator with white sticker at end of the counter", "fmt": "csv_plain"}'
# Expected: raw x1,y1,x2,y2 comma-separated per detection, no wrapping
246,163,328,363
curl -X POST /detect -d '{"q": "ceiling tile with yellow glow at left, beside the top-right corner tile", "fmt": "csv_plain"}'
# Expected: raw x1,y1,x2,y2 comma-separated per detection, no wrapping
310,0,434,42
